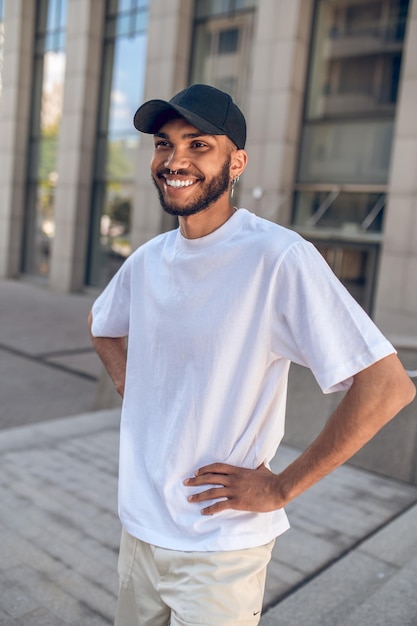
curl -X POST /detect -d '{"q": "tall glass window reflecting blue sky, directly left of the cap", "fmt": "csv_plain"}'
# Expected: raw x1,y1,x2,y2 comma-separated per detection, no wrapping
87,0,148,286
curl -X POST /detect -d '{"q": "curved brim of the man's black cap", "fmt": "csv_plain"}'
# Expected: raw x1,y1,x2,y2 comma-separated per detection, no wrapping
133,100,225,135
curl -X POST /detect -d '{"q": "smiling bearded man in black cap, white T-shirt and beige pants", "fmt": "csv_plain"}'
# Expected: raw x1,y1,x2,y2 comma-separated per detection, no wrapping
90,85,415,626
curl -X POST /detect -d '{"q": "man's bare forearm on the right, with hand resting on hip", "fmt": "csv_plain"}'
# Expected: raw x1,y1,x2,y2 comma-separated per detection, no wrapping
185,355,416,515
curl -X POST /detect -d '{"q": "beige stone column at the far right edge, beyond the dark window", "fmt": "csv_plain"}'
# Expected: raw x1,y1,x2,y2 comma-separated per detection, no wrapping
375,0,417,344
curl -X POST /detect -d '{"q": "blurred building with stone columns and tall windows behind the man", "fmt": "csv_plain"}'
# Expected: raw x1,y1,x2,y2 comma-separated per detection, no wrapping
0,0,417,347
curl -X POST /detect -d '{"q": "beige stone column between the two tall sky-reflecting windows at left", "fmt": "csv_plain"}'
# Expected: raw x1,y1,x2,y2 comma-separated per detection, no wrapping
49,0,105,292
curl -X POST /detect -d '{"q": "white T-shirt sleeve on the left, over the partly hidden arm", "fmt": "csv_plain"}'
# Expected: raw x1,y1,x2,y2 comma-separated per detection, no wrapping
91,257,131,337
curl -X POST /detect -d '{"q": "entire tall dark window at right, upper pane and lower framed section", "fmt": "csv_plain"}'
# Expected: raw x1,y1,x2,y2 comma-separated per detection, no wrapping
293,0,408,312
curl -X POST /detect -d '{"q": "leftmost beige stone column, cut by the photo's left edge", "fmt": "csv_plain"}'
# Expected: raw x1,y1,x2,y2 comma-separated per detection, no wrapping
0,0,36,278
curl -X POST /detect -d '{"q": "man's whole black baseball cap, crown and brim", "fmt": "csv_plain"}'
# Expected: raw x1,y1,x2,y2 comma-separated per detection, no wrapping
133,85,246,149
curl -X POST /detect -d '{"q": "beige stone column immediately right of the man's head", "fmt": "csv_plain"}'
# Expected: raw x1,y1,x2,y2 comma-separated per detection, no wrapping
240,0,313,224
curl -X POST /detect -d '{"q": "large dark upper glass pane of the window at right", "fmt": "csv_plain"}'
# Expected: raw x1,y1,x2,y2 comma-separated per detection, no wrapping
298,0,408,184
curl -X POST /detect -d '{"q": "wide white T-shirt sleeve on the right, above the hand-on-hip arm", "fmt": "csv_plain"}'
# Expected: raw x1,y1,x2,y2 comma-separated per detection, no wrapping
273,240,395,393
